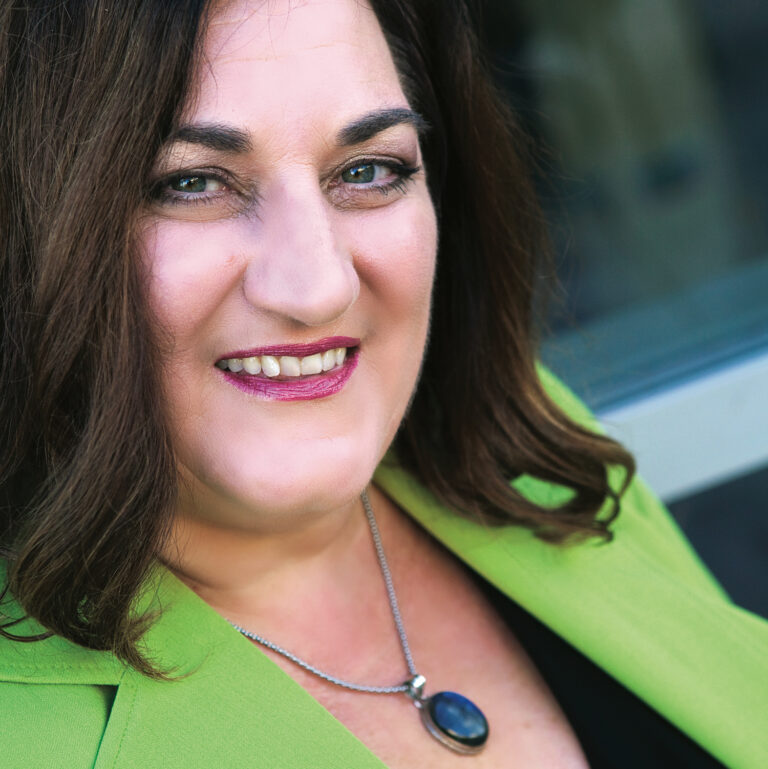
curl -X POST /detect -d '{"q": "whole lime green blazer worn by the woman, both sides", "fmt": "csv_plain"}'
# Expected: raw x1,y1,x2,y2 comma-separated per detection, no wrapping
0,370,768,769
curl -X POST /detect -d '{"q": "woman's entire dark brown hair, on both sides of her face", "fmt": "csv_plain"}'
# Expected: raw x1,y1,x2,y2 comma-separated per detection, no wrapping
0,0,632,674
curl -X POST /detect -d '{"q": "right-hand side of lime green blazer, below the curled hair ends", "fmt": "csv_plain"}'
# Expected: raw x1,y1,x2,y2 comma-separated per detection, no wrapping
376,465,768,769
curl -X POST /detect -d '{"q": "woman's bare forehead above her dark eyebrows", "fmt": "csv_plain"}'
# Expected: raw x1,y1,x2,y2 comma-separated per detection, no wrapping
191,0,407,138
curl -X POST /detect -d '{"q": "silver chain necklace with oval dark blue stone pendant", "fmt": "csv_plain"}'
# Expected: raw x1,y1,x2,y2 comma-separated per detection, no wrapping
230,491,489,754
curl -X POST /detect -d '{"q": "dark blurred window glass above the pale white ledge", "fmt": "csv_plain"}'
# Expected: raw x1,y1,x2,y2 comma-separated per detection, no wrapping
486,0,768,408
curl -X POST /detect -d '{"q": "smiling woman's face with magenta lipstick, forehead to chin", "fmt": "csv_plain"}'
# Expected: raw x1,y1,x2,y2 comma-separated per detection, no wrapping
143,0,436,529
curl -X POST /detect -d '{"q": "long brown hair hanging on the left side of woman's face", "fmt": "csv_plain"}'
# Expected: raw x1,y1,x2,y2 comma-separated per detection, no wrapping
0,0,203,672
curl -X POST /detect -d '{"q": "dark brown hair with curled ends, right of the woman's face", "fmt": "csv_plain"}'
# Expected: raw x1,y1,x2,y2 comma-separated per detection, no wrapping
380,0,634,542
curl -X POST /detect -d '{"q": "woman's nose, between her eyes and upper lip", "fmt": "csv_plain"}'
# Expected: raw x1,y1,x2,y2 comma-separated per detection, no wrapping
243,183,360,326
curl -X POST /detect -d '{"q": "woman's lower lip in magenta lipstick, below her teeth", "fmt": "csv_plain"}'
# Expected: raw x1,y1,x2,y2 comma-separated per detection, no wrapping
217,350,358,401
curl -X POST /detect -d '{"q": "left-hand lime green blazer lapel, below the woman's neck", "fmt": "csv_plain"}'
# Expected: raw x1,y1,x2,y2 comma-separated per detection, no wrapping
100,572,384,769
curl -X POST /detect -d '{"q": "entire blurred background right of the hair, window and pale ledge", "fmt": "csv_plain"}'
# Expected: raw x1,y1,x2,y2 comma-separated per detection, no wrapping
483,0,768,616
